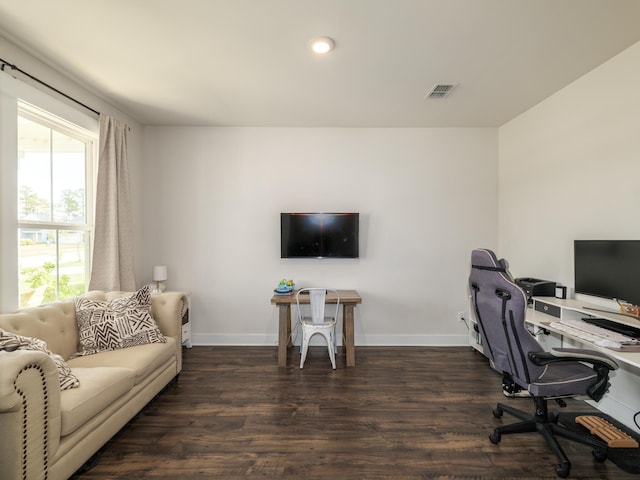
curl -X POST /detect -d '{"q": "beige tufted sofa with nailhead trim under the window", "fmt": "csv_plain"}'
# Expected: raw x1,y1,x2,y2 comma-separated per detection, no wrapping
0,291,188,480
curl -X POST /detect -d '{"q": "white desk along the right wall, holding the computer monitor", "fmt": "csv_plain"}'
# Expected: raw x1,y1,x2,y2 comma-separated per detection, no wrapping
526,297,640,432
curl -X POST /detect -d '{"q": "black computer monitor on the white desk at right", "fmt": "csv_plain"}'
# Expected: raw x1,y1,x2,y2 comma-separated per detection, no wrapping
574,240,640,305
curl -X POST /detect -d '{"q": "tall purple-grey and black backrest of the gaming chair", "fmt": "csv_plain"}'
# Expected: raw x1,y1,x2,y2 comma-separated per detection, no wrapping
469,249,545,388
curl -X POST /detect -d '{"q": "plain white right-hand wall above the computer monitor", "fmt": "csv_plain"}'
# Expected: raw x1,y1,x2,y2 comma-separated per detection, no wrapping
499,43,640,287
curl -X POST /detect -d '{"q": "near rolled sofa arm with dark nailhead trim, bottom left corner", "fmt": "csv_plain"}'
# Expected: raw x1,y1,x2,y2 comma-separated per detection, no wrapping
0,350,61,479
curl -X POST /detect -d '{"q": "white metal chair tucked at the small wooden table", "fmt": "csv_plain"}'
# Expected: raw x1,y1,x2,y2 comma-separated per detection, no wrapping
296,288,340,370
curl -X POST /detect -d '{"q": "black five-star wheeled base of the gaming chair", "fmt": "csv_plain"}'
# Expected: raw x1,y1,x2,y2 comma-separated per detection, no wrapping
489,397,609,478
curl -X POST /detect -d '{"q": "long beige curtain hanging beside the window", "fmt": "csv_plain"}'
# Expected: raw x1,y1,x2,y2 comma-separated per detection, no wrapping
89,114,136,291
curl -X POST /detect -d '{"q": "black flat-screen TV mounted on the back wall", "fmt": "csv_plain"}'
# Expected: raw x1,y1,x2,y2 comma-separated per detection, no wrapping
280,213,360,258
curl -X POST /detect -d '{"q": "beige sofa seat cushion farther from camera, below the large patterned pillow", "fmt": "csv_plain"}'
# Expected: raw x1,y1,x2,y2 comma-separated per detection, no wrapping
69,337,176,384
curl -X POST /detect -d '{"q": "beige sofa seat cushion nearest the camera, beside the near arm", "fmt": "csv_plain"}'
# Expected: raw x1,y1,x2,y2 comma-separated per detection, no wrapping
60,367,135,436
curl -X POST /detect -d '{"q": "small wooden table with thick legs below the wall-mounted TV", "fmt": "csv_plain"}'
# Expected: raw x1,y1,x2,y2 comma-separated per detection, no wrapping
271,290,362,367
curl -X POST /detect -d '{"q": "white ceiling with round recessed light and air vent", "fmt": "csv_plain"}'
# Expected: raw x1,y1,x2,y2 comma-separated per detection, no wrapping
0,0,640,127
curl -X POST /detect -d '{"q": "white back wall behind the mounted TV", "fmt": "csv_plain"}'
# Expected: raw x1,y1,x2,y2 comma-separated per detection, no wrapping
142,127,497,345
